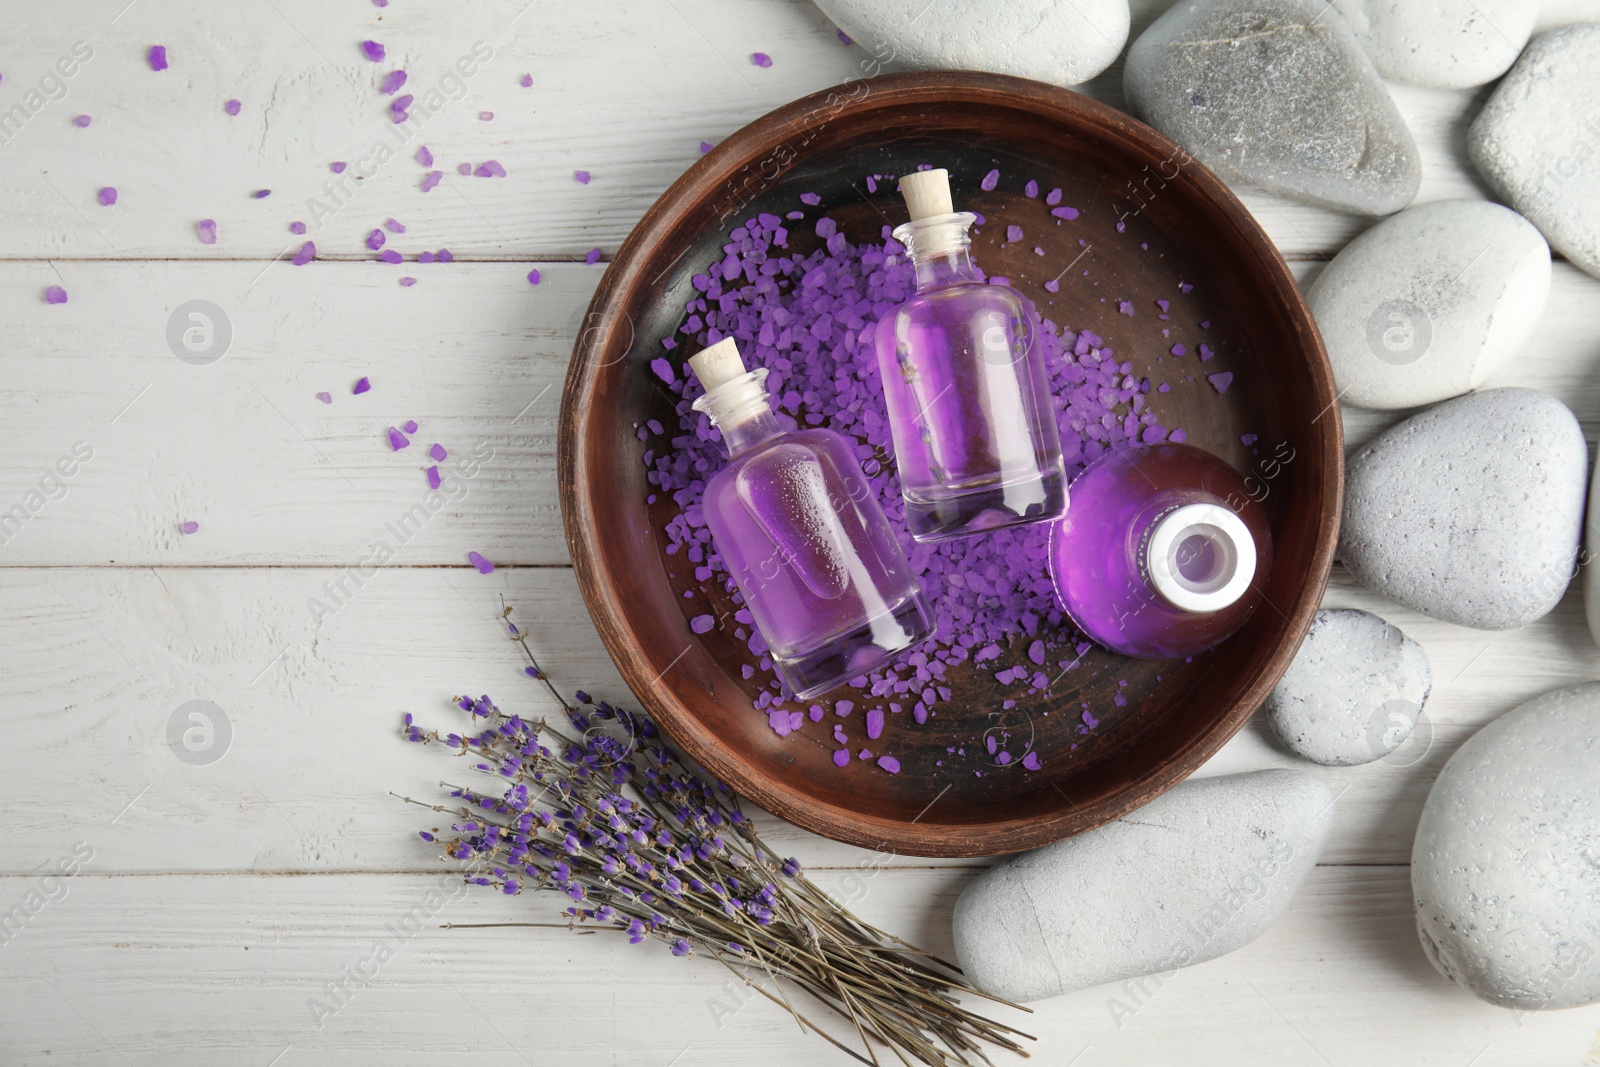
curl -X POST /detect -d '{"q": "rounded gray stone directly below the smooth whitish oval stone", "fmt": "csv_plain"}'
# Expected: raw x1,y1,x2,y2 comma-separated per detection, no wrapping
1339,389,1589,630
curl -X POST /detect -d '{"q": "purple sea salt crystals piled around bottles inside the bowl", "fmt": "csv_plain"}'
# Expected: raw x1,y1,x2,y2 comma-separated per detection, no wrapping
646,201,1177,735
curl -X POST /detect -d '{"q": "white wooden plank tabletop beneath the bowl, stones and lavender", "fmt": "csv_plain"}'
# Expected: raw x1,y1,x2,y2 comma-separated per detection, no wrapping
9,0,1600,1067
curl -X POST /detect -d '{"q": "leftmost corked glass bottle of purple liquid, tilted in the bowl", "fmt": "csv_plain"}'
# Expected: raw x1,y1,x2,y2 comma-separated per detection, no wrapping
690,338,933,699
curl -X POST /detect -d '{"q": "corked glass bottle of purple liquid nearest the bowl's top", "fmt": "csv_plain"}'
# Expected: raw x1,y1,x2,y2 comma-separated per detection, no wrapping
875,170,1067,541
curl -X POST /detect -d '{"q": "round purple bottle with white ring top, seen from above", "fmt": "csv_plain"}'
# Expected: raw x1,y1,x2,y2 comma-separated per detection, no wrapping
1050,445,1272,659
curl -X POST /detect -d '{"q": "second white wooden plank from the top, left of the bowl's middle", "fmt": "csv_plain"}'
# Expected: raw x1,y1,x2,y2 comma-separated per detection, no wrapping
0,254,1600,566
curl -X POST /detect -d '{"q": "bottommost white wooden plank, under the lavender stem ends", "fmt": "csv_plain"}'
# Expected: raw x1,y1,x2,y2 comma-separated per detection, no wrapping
0,870,1600,1067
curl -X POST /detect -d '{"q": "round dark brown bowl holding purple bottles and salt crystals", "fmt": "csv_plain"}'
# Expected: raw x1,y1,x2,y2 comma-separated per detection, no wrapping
560,72,1342,856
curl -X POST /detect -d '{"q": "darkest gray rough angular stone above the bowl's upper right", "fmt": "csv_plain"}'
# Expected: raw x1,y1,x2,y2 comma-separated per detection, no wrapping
1123,0,1422,214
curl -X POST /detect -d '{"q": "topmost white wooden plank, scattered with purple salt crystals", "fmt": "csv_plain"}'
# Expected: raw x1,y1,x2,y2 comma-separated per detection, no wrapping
0,0,1600,259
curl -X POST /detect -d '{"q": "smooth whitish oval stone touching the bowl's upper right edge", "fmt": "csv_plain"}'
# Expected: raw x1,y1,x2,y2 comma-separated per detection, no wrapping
1306,200,1550,408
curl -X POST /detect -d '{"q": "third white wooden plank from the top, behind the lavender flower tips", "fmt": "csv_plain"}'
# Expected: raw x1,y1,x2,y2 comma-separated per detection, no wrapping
0,568,1600,873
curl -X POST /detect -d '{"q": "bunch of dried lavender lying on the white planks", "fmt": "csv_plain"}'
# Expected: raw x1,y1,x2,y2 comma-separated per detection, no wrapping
393,608,1032,1065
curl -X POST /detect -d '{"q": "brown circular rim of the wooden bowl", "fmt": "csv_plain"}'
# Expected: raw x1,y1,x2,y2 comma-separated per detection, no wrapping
557,70,1344,857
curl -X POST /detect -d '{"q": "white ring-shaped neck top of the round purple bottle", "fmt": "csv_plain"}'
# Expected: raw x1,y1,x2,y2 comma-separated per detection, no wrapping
1144,504,1256,613
